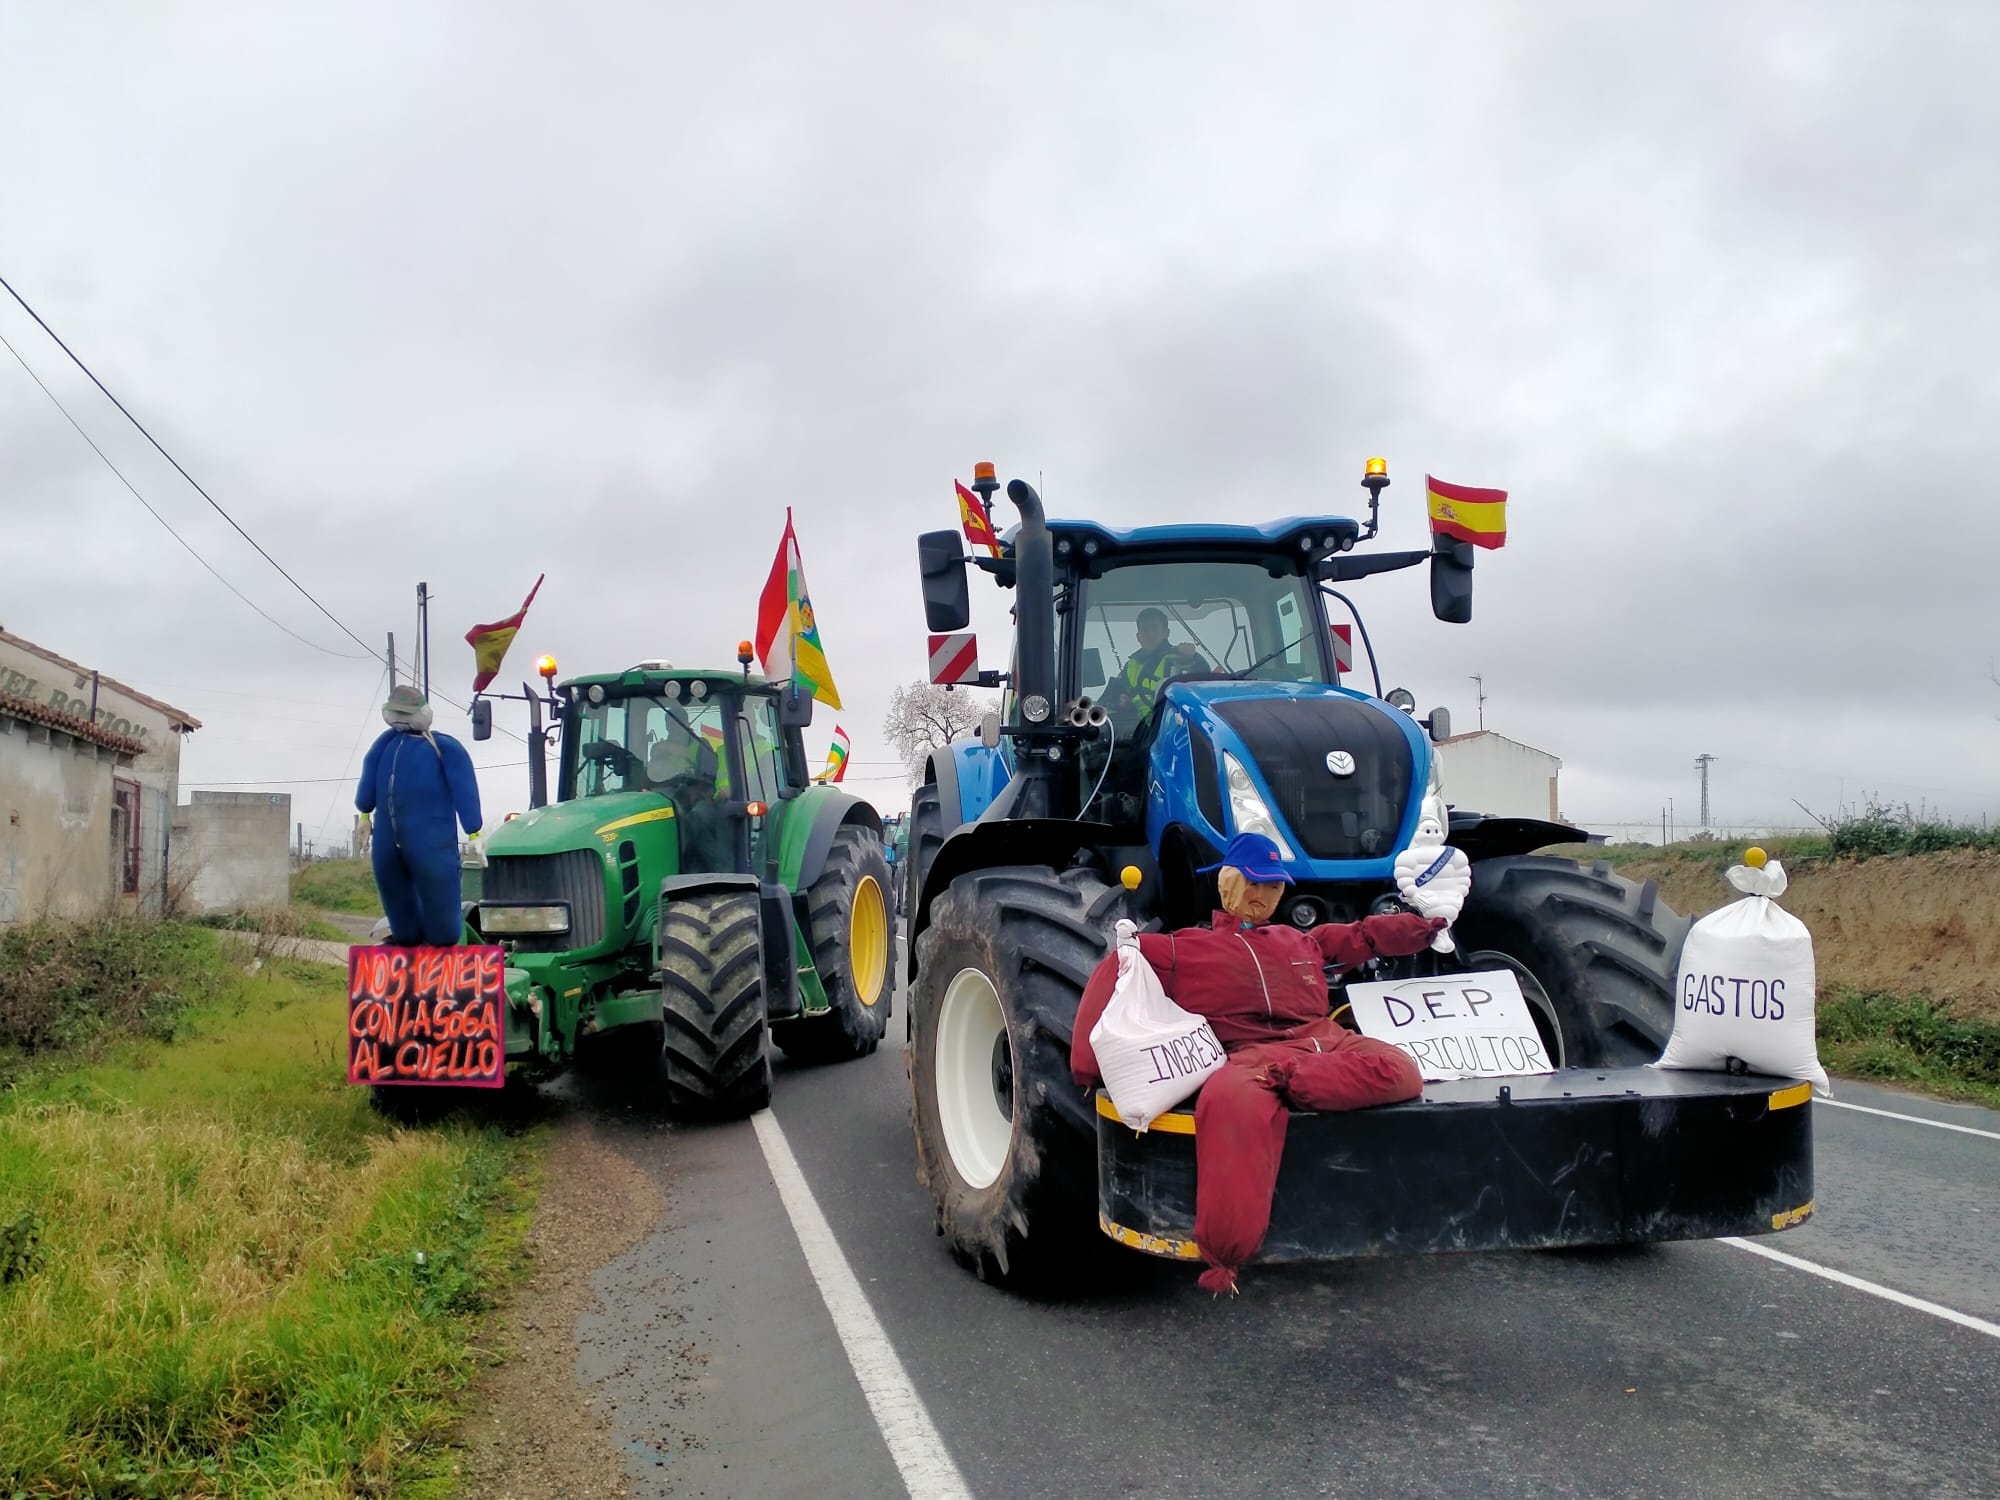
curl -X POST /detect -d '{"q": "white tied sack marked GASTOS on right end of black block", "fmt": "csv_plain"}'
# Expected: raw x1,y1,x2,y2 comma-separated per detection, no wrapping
1652,860,1832,1094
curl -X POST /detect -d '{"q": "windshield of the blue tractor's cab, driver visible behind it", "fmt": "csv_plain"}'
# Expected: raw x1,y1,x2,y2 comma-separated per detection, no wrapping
1066,562,1336,734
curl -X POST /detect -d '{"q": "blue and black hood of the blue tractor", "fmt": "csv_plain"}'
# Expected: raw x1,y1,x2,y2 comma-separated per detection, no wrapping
1148,682,1434,880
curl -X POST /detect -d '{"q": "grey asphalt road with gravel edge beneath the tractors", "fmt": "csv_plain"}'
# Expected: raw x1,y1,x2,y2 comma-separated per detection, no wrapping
574,964,2000,1500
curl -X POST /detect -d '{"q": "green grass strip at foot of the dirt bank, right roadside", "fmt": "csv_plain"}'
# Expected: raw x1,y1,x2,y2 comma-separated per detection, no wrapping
1818,988,2000,1108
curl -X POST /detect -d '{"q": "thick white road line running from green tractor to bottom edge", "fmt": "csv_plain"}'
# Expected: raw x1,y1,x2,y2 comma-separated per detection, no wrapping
750,1110,972,1500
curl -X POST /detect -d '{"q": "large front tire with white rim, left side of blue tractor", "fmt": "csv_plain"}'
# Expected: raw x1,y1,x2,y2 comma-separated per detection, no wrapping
908,866,1126,1286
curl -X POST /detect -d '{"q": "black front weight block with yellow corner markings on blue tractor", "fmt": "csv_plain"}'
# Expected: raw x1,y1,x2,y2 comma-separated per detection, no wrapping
1096,1068,1812,1262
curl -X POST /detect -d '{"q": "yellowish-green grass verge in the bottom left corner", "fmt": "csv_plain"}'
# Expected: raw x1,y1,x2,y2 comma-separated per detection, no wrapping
0,932,540,1500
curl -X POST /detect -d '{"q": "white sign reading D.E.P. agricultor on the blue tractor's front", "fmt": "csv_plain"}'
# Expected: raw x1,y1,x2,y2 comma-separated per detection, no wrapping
1346,968,1556,1082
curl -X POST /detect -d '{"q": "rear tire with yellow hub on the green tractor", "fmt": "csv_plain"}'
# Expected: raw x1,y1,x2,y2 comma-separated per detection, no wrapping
772,824,896,1062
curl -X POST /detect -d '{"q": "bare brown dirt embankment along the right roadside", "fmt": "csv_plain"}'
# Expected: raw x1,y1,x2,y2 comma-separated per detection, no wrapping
1584,850,2000,1020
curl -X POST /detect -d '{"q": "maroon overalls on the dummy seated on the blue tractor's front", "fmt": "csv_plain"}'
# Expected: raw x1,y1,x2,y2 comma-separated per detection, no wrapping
1070,912,1444,1292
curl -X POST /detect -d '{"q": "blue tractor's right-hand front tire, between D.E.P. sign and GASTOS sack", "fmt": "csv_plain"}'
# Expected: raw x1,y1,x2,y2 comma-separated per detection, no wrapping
1452,854,1688,1068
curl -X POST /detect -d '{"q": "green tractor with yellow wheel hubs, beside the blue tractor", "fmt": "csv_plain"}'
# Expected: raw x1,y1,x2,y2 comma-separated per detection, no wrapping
376,650,894,1118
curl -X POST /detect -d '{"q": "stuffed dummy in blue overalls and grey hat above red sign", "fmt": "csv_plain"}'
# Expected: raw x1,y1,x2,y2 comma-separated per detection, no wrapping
354,686,480,948
